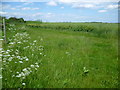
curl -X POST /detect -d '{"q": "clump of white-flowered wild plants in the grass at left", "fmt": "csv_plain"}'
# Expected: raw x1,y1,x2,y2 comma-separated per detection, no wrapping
2,28,46,87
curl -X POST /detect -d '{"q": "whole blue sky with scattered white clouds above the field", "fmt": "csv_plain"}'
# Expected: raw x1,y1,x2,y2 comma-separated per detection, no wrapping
0,0,119,23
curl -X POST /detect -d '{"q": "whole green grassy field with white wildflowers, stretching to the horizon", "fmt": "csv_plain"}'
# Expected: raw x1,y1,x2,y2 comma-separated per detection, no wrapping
2,21,118,88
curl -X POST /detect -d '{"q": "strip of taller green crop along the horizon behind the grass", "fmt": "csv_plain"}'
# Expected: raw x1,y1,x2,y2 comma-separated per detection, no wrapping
27,22,118,38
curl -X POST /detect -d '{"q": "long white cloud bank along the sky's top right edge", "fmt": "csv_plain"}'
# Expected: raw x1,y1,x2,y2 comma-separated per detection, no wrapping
55,0,119,9
